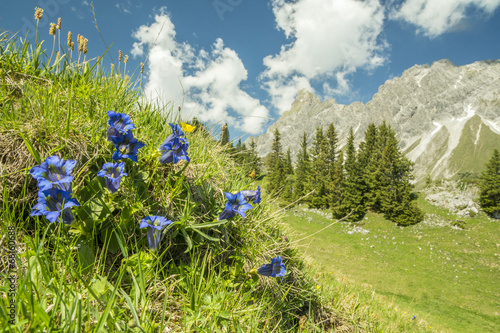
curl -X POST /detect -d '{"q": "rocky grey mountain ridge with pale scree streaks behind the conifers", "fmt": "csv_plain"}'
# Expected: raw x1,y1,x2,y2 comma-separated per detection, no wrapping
247,60,500,181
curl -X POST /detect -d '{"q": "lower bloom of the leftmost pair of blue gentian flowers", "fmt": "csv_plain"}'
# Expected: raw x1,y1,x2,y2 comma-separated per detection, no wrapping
31,188,80,224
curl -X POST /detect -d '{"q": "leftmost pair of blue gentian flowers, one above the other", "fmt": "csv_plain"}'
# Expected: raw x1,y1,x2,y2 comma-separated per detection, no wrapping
30,156,80,224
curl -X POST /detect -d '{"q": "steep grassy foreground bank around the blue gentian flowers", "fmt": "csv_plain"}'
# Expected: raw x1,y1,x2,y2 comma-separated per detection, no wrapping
0,26,340,333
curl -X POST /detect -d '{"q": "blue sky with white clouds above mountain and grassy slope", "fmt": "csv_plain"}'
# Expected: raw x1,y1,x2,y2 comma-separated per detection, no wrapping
0,0,500,139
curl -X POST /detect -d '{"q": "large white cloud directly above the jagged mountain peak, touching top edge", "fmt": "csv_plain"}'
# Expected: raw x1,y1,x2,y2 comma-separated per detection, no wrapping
261,0,385,112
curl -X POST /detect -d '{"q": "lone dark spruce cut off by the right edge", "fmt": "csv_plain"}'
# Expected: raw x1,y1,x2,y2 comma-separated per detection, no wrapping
479,149,500,218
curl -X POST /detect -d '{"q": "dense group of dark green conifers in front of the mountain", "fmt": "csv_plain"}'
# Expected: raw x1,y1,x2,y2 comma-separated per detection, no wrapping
265,122,423,225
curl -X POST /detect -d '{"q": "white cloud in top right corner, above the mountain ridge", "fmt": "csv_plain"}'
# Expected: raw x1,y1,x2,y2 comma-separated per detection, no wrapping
391,0,500,38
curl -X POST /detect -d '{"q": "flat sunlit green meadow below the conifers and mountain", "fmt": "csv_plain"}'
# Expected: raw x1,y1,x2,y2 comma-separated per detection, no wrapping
285,198,500,332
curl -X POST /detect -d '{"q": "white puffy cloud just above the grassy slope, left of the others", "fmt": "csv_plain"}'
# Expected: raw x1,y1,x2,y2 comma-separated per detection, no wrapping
131,8,269,134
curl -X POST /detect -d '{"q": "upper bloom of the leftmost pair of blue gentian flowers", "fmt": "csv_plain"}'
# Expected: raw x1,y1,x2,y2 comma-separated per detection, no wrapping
30,155,76,192
